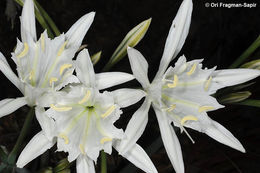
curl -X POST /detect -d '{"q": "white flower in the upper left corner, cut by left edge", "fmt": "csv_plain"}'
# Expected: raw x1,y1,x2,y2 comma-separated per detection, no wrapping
0,0,95,117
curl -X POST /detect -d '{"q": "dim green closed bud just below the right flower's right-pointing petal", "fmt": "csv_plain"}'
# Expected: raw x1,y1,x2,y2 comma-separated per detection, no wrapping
219,91,251,104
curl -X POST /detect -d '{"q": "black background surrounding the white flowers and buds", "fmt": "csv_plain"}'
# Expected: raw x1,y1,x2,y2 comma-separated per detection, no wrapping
0,0,260,173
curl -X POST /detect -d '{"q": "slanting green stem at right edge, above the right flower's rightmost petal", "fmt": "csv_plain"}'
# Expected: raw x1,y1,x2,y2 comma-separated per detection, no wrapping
229,35,260,68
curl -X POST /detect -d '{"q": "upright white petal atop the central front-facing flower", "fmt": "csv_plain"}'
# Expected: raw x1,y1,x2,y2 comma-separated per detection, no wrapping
76,49,95,87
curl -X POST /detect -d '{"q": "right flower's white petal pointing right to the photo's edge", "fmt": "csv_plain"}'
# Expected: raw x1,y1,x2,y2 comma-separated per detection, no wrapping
209,69,260,94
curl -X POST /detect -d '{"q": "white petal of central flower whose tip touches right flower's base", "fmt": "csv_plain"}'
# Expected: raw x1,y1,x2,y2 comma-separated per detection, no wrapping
112,88,146,108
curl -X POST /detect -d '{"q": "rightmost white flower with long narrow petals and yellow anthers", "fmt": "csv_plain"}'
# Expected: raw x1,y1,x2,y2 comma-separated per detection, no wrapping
119,0,260,173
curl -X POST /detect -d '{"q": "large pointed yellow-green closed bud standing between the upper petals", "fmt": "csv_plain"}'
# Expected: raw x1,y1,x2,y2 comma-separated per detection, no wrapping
103,18,152,71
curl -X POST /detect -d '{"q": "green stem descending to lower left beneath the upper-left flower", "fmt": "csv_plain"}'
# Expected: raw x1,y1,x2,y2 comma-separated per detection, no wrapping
7,107,34,164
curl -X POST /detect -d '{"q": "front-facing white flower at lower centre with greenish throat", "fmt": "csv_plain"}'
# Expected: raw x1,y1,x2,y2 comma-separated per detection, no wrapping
17,49,157,173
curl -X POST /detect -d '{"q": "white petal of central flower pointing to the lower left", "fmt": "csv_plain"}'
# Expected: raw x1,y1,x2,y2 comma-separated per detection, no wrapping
16,131,55,168
